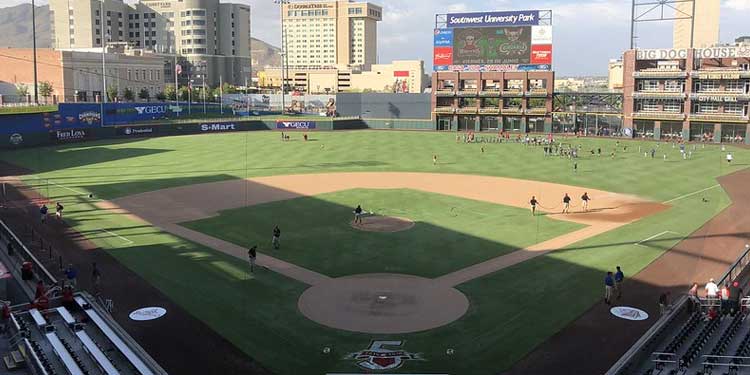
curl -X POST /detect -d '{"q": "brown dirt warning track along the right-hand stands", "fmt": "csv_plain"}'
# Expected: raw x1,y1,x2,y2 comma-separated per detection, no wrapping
506,169,750,375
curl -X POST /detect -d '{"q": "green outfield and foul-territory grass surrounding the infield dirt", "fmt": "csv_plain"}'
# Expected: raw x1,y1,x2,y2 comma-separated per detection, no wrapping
0,131,750,374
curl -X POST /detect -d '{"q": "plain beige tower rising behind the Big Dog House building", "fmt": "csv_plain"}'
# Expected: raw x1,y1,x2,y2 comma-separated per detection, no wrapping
673,0,721,49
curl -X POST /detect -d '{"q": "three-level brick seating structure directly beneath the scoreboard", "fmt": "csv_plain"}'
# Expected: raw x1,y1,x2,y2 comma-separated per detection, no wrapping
432,71,555,132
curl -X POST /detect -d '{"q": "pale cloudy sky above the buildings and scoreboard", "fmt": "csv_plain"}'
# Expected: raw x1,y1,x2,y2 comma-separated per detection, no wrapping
5,0,750,76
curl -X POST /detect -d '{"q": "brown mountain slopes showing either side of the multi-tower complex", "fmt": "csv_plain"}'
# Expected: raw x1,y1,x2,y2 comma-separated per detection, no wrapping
0,4,281,75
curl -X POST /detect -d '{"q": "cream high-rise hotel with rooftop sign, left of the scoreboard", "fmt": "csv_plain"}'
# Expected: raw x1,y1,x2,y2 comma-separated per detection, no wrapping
282,0,383,70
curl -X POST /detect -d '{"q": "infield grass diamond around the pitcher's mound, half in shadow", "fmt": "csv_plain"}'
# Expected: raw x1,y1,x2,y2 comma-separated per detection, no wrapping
183,189,583,278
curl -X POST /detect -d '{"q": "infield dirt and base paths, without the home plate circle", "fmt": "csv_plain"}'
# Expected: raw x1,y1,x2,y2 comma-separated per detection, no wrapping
114,173,666,286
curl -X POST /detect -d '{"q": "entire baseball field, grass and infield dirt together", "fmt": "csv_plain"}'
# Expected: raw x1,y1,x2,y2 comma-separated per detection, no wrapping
0,131,750,374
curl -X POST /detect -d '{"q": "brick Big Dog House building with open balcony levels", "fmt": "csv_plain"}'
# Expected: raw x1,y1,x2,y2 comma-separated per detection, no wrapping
623,45,750,142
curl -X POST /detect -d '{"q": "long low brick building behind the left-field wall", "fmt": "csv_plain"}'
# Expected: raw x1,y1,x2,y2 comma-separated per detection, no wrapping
0,46,164,102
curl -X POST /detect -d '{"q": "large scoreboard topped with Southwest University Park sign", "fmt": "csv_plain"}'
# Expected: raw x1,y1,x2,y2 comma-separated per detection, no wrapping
433,10,552,71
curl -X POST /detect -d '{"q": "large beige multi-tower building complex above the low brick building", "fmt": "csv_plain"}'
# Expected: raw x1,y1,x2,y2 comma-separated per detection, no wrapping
50,0,251,86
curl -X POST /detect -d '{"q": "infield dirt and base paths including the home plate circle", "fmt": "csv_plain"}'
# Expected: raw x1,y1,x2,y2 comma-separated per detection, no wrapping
106,173,667,334
